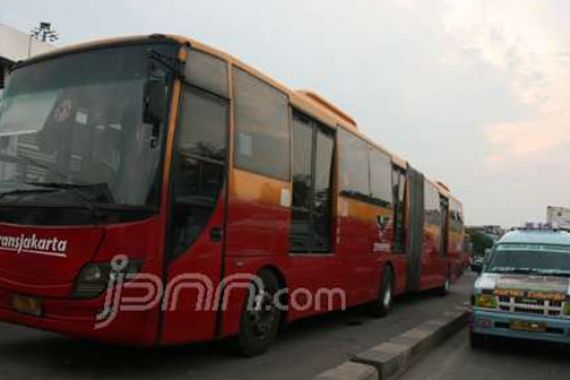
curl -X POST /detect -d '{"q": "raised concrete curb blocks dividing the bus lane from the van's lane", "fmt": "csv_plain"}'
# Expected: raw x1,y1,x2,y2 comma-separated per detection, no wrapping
313,307,467,380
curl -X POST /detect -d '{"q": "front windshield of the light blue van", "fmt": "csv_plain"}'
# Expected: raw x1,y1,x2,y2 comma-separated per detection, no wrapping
487,244,570,276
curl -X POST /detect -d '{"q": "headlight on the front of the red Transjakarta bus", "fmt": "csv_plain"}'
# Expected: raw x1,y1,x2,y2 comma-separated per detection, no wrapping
72,260,142,299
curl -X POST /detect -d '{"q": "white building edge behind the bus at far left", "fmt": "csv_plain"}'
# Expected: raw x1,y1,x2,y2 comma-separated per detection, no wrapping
0,24,54,94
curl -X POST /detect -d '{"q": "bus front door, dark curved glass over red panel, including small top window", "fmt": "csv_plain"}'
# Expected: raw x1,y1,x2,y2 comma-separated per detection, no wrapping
160,52,229,344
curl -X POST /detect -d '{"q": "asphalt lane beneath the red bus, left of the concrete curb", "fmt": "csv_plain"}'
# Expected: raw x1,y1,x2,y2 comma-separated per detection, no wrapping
0,274,474,380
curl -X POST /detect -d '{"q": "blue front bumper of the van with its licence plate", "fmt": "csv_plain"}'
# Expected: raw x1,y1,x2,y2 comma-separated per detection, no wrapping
469,309,570,344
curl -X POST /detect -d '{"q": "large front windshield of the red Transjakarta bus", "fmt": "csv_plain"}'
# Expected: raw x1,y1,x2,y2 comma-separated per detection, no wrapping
0,44,172,206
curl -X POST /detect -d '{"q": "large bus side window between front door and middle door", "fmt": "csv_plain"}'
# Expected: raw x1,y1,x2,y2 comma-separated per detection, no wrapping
234,69,289,180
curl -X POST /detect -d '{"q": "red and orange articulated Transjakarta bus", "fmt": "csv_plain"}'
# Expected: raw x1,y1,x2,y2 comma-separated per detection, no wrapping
0,35,464,355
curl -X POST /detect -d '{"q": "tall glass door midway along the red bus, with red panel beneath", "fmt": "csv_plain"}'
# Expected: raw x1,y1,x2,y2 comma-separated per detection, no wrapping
289,111,336,313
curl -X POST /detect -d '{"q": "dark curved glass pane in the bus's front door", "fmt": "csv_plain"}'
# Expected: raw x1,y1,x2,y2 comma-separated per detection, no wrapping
171,86,228,255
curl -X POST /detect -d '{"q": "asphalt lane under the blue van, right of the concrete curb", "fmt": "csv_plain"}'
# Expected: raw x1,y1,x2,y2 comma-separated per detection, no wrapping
400,328,570,380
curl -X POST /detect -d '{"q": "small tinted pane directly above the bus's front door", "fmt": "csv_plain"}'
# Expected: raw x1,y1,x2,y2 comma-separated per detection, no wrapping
184,50,228,98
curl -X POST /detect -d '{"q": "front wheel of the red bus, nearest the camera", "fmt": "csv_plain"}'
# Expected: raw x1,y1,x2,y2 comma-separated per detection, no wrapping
237,270,281,357
